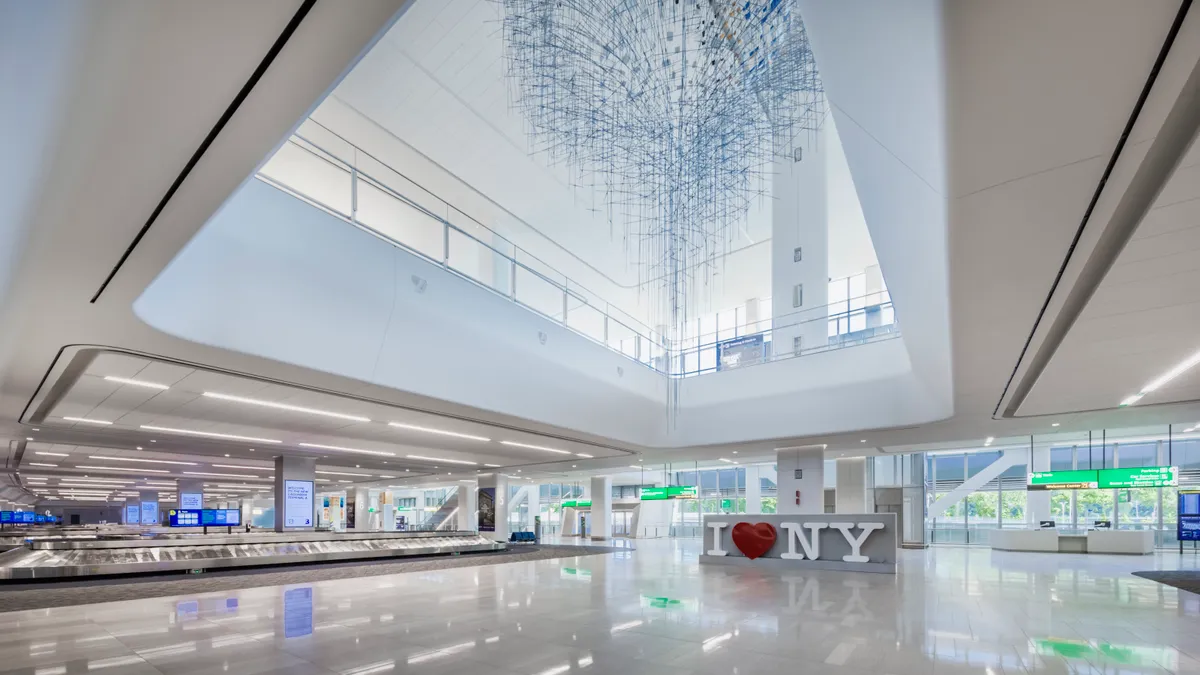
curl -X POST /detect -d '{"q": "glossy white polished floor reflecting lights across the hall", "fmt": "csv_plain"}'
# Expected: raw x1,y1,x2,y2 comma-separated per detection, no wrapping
0,540,1200,675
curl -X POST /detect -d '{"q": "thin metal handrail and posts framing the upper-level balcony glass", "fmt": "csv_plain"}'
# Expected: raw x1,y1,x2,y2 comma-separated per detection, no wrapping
256,127,899,377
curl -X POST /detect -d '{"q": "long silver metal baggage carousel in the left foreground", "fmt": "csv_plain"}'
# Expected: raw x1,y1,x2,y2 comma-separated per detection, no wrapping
0,532,505,583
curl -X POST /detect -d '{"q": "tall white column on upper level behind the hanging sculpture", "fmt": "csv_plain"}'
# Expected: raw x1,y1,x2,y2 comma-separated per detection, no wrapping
760,125,829,357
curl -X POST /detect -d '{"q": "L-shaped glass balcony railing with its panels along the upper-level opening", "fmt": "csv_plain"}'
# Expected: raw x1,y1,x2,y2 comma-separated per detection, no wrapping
257,120,900,377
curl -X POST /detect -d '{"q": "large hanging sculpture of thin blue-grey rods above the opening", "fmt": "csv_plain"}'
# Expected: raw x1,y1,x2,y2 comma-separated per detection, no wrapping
500,0,824,330
